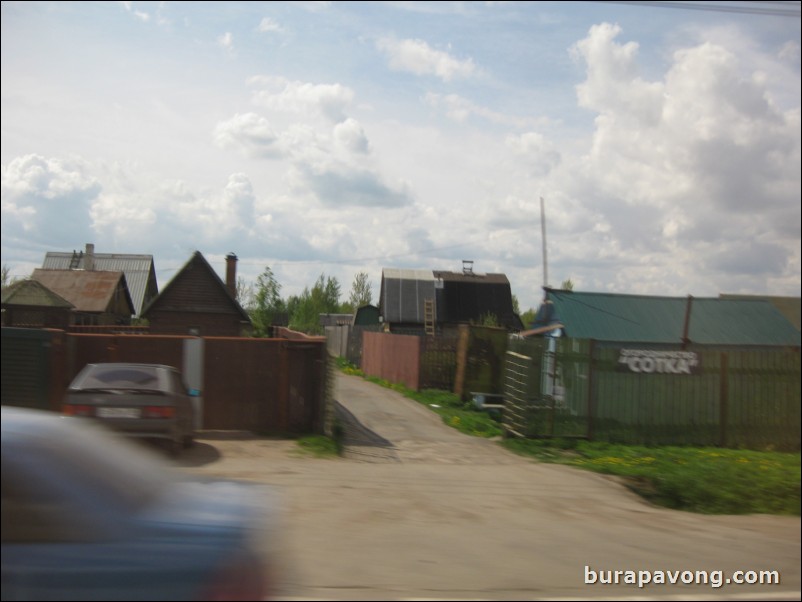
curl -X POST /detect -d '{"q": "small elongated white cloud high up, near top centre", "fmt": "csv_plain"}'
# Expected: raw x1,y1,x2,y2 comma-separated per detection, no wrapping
376,37,477,82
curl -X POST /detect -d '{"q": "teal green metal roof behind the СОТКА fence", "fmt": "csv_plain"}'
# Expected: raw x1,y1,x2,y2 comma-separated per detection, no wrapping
547,290,800,346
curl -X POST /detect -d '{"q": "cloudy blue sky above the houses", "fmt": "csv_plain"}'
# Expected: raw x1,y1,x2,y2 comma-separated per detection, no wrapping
1,1,802,311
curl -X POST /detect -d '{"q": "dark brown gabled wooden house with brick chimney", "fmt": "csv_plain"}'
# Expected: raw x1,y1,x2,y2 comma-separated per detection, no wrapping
142,251,251,337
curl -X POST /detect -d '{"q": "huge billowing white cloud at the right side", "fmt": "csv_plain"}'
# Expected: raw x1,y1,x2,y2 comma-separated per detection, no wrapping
559,24,800,292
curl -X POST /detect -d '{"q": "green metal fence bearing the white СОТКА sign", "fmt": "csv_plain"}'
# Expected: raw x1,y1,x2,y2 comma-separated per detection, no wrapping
504,339,801,449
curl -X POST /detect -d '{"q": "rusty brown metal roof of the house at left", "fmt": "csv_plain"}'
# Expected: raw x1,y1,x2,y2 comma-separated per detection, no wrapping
31,268,134,314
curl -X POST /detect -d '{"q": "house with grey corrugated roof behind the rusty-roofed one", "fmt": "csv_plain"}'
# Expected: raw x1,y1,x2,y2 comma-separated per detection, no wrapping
42,243,159,316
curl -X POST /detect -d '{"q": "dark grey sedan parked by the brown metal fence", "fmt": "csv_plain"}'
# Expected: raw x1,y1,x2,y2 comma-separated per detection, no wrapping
62,363,195,455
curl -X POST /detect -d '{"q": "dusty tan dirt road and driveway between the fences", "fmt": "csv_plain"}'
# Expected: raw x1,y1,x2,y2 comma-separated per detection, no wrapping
180,374,800,600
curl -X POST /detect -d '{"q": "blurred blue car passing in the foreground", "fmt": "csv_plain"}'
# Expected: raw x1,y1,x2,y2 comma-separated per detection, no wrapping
1,406,279,601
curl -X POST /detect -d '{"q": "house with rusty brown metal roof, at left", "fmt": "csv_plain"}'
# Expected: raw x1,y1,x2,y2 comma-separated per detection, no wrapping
31,268,134,326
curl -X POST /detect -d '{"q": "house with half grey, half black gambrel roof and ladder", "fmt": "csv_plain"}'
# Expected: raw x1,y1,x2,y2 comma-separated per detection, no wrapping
379,261,523,331
